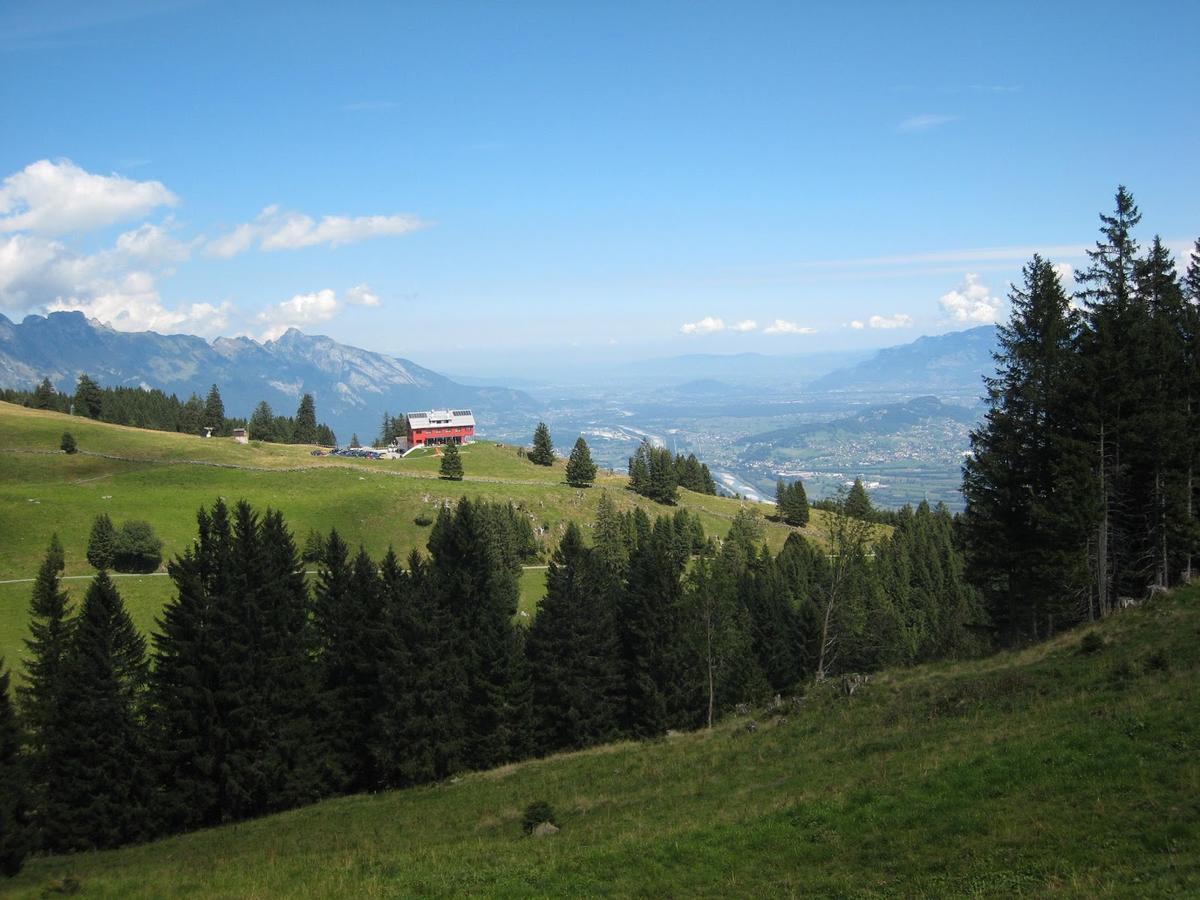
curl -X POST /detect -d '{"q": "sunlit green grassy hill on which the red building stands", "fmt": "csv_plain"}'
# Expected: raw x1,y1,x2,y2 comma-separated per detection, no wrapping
0,402,823,677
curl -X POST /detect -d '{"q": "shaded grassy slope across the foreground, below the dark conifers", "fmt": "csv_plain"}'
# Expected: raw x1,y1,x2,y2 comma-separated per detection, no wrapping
0,588,1200,898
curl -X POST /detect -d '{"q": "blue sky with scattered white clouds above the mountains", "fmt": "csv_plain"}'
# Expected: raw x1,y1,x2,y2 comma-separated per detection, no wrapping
0,2,1200,372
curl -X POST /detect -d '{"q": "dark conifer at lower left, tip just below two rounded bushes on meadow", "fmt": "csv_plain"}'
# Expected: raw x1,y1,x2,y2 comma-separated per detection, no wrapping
41,571,150,852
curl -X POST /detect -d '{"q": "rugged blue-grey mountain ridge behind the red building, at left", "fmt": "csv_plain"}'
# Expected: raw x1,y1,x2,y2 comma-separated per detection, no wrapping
0,312,535,440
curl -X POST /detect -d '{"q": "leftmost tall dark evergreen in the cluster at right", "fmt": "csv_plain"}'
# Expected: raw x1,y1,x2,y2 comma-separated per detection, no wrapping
962,256,1099,640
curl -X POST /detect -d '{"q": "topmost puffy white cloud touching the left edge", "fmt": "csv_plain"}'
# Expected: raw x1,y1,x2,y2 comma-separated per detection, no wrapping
0,160,179,234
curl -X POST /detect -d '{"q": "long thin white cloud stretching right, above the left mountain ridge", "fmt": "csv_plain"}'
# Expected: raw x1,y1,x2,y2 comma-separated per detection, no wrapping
206,205,426,258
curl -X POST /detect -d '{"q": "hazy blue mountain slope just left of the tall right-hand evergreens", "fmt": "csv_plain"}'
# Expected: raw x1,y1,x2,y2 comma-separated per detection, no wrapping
809,325,996,397
